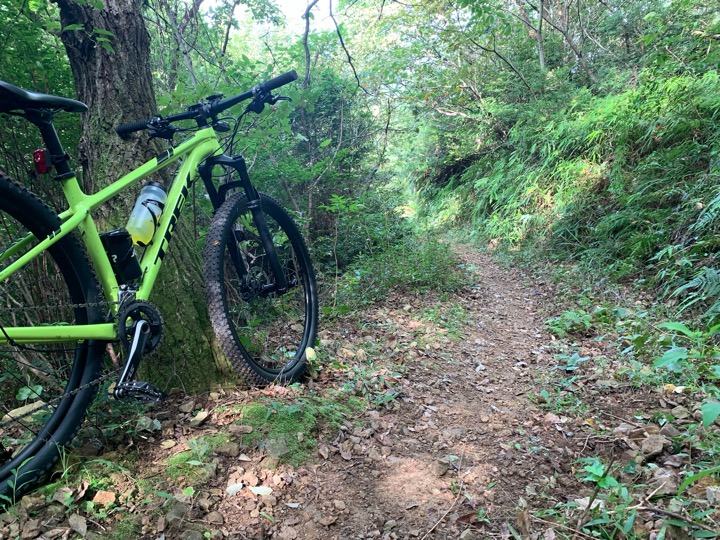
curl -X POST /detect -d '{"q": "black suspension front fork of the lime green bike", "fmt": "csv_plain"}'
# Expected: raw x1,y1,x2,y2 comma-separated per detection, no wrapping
199,155,288,295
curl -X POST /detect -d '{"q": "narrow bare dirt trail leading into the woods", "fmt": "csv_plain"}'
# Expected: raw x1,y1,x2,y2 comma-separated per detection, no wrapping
278,253,558,539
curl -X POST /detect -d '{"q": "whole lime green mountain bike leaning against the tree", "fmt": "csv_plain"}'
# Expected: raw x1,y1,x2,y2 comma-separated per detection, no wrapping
0,71,318,505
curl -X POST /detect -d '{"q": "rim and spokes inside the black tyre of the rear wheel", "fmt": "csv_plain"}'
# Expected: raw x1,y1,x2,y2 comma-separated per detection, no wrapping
0,202,88,480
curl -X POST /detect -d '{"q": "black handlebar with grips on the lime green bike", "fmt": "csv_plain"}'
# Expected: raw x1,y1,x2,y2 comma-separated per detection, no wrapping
115,70,298,137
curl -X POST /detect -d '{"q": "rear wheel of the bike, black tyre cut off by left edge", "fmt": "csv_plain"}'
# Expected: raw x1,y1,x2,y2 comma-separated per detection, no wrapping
0,176,103,506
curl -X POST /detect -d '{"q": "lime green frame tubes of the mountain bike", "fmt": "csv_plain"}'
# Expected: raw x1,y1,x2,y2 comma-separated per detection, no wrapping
0,127,221,345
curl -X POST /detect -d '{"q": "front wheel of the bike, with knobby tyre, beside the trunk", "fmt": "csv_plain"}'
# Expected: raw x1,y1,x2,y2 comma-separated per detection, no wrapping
204,193,318,385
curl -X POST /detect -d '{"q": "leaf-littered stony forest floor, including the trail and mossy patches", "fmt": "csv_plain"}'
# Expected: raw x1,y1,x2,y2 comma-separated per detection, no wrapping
0,250,717,540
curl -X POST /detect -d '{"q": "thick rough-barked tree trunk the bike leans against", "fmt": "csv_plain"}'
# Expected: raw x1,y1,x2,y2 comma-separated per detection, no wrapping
55,0,233,391
